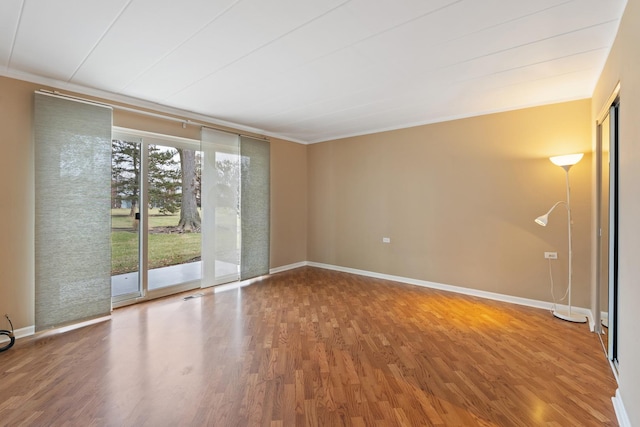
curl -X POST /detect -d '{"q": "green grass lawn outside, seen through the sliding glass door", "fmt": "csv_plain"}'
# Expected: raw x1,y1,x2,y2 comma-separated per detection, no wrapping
111,209,237,275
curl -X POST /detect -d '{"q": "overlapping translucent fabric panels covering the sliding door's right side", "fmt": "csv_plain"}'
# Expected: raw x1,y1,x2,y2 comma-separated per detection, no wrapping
202,128,270,286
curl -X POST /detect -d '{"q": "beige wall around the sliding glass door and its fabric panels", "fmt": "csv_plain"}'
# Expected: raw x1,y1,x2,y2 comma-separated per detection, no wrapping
0,77,307,329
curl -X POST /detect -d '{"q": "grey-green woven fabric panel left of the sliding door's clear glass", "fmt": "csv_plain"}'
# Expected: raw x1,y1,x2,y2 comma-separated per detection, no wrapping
34,93,112,331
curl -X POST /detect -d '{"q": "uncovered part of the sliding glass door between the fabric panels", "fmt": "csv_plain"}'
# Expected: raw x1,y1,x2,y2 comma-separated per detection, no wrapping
111,130,202,305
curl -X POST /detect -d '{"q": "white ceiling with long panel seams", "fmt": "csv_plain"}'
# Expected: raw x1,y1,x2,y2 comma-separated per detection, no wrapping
0,0,626,143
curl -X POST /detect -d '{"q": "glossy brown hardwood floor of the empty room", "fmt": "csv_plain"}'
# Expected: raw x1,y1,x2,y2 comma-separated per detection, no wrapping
0,267,616,427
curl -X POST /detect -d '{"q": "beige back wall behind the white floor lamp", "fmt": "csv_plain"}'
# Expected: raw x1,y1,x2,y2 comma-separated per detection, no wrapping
308,100,591,307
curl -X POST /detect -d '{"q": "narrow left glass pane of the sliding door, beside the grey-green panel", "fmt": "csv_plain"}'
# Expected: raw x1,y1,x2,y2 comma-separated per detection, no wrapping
111,139,142,301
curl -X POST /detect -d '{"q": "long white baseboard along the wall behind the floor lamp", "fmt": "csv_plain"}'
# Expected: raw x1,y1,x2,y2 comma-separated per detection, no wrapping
305,261,594,331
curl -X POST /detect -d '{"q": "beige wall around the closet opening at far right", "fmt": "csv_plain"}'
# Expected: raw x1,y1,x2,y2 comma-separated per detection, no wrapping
592,0,640,426
